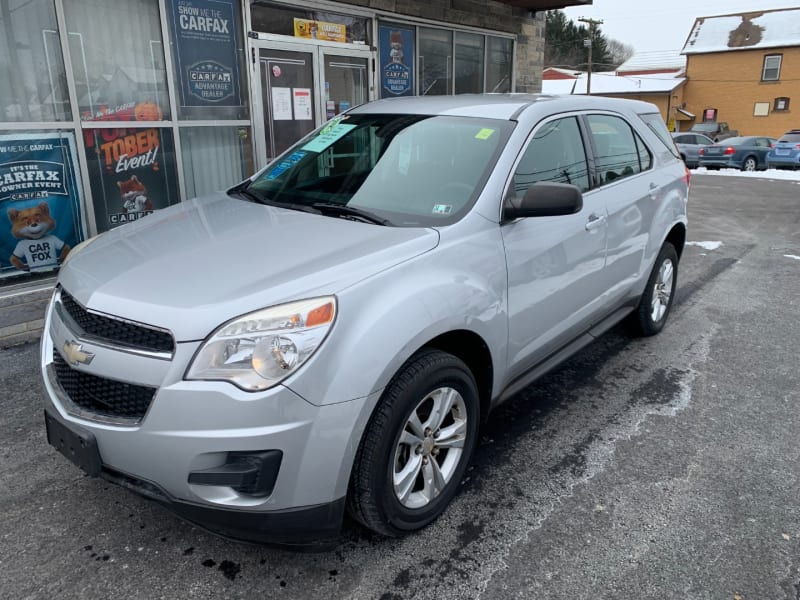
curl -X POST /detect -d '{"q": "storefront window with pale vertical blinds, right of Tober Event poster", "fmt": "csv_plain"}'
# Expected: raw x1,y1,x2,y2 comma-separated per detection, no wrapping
181,127,254,198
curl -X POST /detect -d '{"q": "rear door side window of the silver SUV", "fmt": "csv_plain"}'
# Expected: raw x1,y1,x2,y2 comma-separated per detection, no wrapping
586,115,653,185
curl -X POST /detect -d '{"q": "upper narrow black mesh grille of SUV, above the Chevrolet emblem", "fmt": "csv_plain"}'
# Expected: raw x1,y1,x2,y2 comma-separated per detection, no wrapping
61,289,175,353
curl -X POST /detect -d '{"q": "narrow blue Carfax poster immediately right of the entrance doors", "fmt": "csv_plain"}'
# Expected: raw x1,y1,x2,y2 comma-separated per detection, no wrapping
378,23,414,98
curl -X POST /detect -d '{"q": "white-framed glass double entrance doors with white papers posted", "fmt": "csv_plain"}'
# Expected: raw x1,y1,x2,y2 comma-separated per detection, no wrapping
253,41,374,167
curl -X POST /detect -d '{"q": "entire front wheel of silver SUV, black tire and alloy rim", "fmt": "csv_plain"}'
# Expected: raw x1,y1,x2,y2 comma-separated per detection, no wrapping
348,350,480,536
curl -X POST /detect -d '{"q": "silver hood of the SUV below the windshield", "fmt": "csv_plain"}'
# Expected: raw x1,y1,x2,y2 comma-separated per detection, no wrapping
59,193,439,341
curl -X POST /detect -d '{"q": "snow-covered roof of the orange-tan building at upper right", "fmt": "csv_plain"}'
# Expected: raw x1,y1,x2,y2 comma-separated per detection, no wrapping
682,8,800,54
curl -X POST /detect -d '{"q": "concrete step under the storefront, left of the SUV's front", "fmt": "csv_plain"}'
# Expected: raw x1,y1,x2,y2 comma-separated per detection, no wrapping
0,279,55,348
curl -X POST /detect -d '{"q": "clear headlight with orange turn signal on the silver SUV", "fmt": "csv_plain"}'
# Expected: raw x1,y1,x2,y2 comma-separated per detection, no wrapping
186,296,336,392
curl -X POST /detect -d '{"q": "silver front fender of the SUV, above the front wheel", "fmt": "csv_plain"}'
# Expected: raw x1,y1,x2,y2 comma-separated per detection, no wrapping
285,225,508,404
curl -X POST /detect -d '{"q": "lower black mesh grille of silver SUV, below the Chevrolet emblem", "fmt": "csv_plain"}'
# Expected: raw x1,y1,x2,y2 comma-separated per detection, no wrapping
53,350,156,420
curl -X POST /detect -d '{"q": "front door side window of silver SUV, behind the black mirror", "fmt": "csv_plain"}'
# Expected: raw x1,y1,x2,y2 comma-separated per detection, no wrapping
513,117,589,197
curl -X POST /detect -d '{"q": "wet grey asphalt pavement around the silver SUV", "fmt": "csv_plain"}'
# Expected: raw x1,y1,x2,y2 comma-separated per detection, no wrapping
0,175,800,600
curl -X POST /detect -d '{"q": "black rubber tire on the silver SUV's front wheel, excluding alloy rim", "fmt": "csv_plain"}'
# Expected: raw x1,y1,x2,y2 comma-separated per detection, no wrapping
347,350,480,537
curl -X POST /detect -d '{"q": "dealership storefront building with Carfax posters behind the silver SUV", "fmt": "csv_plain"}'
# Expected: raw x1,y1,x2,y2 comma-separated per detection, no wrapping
0,0,591,285
